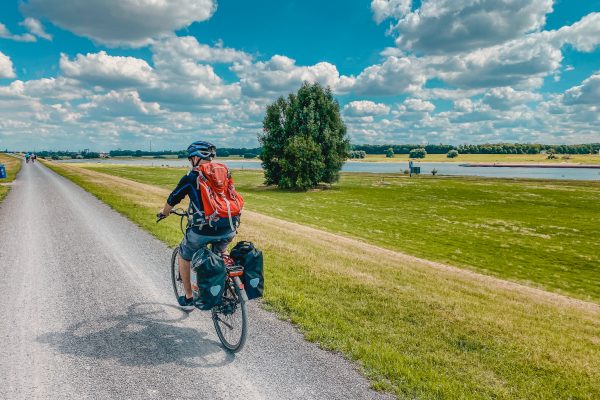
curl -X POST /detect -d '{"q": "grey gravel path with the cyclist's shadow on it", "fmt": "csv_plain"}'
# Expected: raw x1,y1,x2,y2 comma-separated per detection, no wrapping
0,163,388,400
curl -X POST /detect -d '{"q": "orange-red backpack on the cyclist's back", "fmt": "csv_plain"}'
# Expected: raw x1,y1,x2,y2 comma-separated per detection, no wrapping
196,163,244,231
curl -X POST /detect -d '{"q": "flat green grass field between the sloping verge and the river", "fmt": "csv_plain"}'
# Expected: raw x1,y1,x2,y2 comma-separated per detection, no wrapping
76,165,600,302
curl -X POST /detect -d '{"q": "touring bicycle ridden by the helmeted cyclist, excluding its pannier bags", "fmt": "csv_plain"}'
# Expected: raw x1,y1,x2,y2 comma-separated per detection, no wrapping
157,209,248,353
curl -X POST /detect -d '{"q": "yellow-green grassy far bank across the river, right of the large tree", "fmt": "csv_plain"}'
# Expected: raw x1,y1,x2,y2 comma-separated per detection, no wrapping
354,154,600,164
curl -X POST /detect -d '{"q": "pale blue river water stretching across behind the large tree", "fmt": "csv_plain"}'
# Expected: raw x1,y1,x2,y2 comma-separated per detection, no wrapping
61,158,600,180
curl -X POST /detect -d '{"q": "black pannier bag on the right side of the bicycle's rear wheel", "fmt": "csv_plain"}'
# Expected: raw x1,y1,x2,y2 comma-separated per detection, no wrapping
230,241,265,299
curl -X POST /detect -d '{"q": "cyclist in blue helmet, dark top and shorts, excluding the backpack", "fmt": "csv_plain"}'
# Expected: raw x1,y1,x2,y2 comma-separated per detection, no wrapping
157,141,240,310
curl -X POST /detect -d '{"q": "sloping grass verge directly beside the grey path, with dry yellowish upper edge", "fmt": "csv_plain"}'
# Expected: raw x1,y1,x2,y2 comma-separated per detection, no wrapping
45,160,600,399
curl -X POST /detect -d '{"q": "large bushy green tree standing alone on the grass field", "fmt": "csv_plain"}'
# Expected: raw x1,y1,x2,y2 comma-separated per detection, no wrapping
258,82,350,190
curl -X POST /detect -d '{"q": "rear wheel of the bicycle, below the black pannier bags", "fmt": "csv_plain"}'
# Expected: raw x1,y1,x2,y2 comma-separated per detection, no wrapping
212,280,248,353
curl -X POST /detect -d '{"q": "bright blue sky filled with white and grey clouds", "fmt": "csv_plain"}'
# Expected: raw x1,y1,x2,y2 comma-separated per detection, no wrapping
0,0,600,150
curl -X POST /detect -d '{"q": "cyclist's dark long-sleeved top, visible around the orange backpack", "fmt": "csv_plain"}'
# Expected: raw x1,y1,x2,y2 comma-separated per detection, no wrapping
167,170,239,236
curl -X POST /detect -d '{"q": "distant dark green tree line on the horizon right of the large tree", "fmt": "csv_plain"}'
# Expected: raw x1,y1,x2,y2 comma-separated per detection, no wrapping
352,143,600,154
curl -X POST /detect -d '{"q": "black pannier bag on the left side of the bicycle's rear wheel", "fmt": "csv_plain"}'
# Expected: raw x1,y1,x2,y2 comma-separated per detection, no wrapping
192,248,227,310
